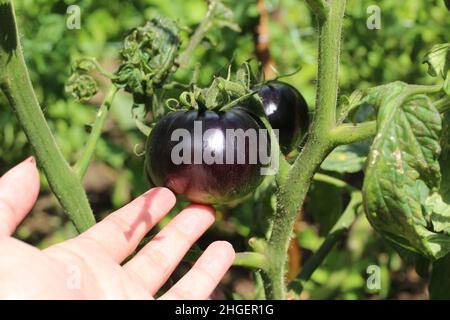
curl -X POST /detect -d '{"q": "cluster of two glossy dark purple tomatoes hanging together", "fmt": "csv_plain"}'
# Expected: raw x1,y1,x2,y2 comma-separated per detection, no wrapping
145,82,309,204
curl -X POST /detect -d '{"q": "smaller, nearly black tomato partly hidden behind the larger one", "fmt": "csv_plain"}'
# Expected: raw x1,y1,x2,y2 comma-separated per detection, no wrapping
258,81,309,154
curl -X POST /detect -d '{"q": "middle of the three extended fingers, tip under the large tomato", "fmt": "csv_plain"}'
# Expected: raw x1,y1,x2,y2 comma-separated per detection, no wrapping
124,205,214,295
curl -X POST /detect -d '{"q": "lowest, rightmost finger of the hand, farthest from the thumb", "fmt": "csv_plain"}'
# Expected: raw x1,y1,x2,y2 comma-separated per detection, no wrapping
160,241,235,300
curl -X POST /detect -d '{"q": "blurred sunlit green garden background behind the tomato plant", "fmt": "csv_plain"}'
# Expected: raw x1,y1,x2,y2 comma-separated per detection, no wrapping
0,0,450,299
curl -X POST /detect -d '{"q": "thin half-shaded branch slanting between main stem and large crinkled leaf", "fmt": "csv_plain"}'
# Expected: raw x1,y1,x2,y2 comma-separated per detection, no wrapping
289,191,362,294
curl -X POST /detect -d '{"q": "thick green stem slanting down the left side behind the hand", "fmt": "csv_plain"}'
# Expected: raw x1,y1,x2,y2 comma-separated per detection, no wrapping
0,0,95,232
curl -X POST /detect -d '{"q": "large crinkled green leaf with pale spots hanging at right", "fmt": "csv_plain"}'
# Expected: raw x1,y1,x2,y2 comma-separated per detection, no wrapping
363,90,450,259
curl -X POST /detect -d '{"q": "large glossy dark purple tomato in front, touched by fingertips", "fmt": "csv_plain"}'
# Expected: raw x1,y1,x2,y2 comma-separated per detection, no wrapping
145,107,270,204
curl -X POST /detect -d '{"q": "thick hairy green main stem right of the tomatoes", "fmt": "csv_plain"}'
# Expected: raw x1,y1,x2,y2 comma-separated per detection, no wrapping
263,0,346,299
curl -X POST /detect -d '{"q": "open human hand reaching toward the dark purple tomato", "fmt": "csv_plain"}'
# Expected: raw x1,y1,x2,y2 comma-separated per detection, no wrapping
0,158,234,299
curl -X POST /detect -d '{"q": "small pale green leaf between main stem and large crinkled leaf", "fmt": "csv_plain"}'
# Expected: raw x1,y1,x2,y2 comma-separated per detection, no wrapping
321,142,369,173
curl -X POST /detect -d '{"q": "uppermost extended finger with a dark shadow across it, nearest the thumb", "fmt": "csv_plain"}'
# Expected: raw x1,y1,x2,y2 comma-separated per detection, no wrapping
63,188,176,263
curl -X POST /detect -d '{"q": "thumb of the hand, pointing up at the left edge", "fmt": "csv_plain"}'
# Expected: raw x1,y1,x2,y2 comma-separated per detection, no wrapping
0,157,39,236
